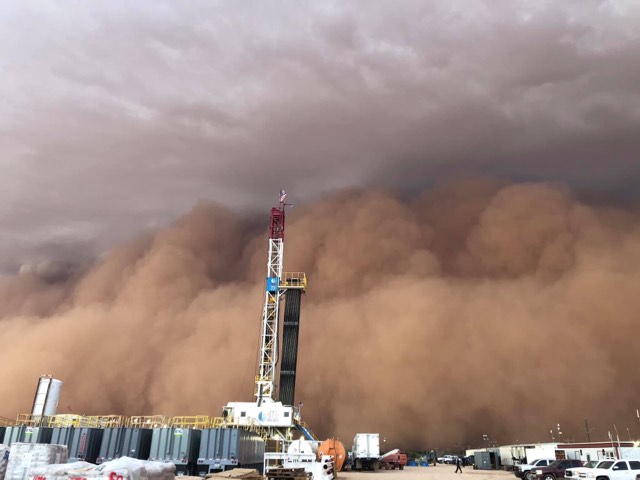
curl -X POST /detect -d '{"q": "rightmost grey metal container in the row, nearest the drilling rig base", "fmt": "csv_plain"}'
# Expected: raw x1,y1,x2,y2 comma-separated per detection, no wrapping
197,428,265,477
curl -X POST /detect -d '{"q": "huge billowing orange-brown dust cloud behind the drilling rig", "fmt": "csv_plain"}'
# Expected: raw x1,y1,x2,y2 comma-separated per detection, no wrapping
0,181,640,449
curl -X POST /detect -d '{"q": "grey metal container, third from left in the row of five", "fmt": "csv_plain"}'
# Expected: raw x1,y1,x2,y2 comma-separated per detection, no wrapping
96,427,153,463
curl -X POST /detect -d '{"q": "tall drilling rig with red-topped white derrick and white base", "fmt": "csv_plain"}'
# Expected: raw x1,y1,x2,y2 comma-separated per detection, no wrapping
222,190,312,440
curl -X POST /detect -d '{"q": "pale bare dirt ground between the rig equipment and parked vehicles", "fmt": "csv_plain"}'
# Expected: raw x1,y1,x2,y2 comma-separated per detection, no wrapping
338,465,517,480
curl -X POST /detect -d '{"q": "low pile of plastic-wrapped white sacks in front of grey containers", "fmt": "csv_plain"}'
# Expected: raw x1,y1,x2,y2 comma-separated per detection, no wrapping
23,457,176,480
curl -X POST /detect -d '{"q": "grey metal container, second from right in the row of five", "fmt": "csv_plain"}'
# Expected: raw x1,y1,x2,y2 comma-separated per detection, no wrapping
149,427,201,475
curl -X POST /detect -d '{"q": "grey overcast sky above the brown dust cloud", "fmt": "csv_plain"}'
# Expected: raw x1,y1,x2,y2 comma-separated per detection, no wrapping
0,0,640,274
